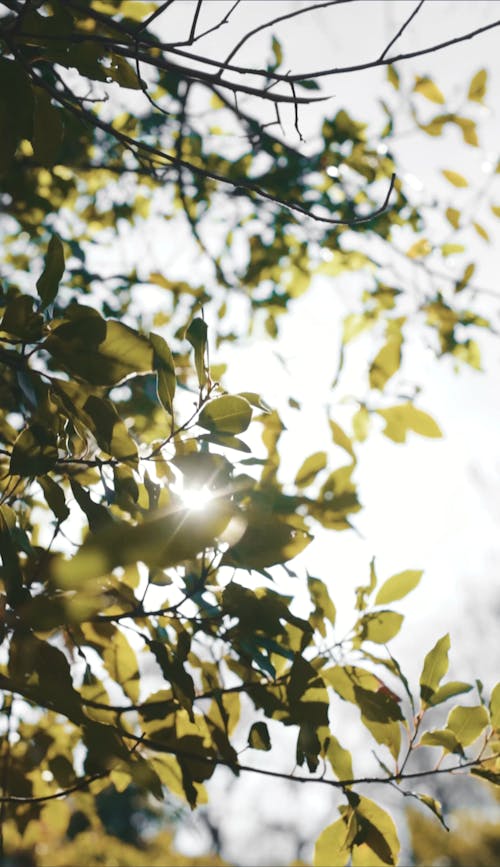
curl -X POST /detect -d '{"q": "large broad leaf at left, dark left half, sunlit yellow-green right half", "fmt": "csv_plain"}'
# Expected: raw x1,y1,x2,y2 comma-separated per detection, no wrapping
44,305,153,385
